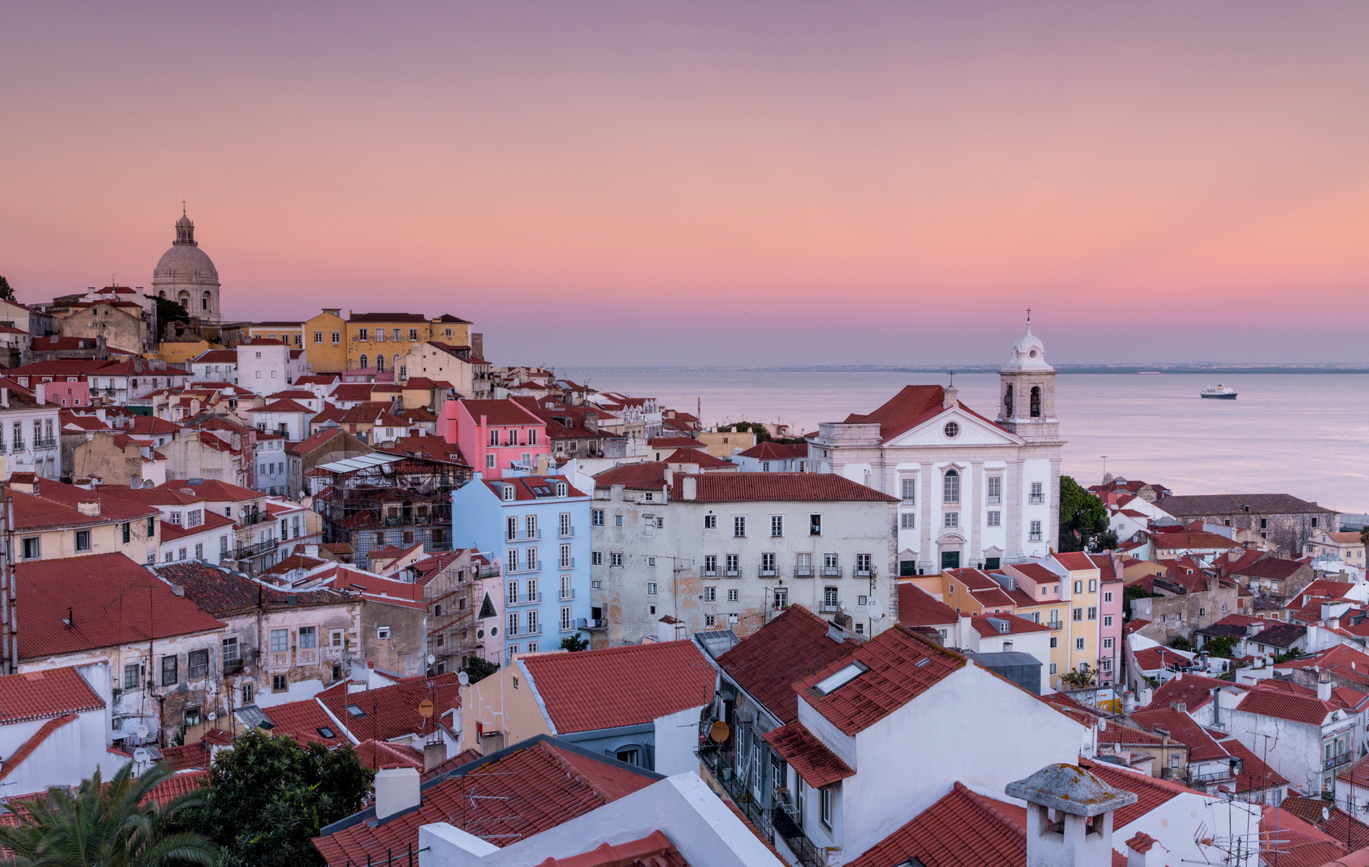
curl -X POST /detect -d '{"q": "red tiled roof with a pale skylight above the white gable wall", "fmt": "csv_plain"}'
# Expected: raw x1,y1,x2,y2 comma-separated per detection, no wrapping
794,626,965,734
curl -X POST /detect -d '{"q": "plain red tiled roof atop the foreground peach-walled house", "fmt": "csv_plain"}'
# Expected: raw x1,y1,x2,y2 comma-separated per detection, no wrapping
520,641,715,734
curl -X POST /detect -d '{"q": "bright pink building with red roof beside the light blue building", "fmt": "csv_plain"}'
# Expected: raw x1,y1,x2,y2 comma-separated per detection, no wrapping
438,399,552,479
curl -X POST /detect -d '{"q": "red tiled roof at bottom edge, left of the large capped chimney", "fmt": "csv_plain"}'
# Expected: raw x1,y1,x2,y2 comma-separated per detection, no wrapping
849,782,1027,867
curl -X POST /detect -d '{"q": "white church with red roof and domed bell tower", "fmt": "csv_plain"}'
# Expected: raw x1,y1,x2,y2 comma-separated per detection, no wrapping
809,321,1064,575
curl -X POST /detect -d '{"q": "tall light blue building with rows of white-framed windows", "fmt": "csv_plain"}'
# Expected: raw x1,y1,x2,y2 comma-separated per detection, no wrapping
452,473,590,660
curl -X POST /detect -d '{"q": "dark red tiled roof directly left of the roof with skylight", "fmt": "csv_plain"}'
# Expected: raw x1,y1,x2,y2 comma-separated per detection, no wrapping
717,605,857,723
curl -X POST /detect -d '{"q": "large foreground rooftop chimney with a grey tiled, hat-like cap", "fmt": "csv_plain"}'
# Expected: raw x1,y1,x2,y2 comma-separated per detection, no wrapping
1005,763,1136,867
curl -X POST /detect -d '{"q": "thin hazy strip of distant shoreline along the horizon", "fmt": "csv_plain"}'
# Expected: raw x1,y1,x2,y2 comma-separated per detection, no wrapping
564,363,1369,377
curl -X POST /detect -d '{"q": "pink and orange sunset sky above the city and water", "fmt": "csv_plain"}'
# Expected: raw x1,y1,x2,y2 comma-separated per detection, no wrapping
0,0,1369,364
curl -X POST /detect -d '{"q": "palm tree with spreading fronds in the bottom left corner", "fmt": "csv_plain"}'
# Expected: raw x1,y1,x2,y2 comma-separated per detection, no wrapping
0,763,218,867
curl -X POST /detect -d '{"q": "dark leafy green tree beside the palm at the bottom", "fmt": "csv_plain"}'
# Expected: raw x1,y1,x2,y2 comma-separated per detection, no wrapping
194,731,374,867
